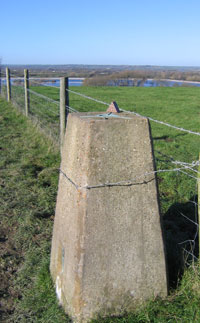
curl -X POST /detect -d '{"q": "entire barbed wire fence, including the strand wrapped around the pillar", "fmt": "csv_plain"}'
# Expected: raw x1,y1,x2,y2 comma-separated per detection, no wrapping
1,66,200,286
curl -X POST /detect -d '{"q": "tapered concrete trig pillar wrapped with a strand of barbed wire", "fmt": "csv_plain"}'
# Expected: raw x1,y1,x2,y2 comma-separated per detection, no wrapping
51,113,167,322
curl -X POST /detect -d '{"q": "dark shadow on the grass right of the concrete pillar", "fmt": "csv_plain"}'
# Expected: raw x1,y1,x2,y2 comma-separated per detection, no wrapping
163,195,199,289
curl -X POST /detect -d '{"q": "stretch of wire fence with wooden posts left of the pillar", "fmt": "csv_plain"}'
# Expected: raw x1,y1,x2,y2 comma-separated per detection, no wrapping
1,69,63,147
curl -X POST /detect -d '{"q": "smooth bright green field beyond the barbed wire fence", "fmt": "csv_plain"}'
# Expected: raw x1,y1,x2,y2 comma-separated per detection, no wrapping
34,87,200,218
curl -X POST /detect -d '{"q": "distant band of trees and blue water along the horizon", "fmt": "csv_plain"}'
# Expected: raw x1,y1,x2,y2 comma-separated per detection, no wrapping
0,62,200,85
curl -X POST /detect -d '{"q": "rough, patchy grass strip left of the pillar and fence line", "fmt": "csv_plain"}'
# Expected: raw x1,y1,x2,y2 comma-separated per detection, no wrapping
0,100,65,322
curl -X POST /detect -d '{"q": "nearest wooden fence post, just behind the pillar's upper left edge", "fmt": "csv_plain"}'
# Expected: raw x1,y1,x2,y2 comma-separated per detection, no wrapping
60,77,69,151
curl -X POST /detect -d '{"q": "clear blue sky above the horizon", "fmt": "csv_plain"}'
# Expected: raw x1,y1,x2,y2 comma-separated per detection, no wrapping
0,0,200,66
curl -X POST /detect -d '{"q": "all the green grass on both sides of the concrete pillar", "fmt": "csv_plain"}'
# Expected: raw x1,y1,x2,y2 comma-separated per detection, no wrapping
0,87,200,322
